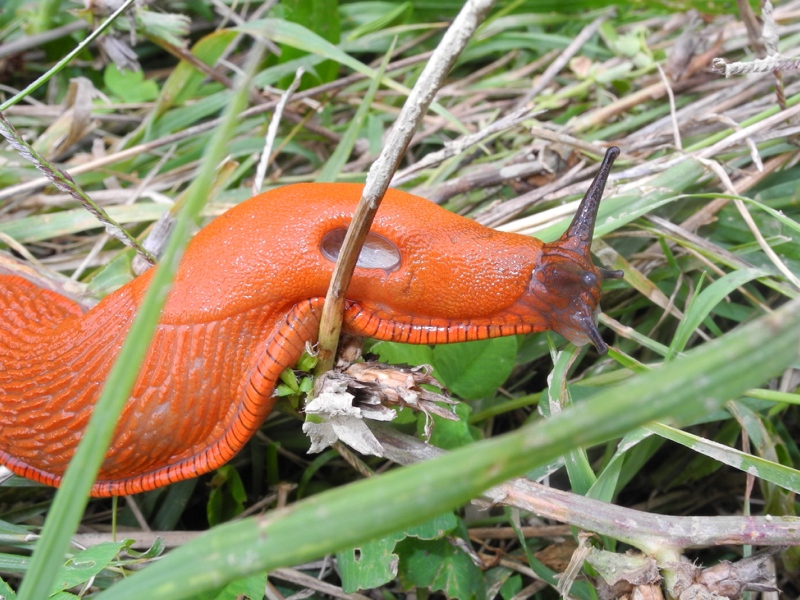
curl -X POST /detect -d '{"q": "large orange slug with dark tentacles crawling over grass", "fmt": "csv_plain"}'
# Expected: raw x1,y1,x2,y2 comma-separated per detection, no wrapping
0,148,622,496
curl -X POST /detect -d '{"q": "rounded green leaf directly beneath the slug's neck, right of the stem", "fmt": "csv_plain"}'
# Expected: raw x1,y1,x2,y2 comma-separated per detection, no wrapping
433,336,517,400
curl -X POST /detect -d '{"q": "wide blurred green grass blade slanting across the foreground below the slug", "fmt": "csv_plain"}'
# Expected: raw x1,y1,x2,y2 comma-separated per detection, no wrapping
97,300,800,600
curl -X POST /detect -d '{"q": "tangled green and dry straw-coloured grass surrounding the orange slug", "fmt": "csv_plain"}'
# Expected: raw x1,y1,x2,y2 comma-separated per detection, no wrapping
0,0,800,600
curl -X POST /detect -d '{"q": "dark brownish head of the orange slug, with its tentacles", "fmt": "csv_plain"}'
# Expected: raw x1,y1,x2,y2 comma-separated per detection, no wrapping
531,147,623,354
